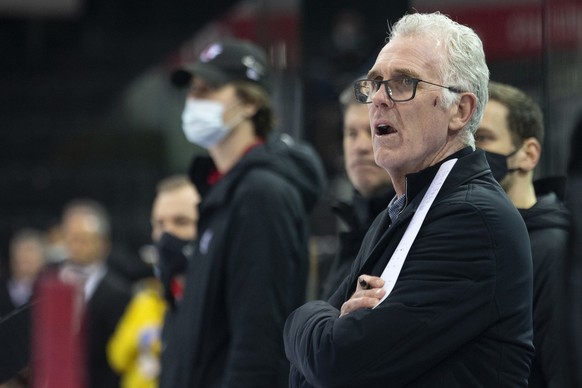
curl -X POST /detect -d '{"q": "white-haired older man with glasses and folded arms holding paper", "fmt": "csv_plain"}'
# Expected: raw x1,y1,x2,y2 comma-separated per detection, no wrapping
284,13,534,388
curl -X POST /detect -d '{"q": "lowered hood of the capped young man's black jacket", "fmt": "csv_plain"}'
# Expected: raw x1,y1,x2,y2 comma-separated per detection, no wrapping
189,134,327,212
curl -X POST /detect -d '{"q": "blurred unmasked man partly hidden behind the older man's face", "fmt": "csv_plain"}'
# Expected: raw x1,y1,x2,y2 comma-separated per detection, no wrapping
321,75,394,299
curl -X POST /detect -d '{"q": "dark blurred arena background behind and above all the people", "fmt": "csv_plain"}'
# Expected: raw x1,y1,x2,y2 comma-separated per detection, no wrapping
0,0,582,271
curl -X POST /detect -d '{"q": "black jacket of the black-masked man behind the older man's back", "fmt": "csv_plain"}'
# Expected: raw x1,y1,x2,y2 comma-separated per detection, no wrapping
519,180,570,388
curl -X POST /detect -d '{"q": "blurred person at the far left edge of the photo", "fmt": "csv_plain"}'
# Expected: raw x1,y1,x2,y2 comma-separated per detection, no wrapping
0,228,46,317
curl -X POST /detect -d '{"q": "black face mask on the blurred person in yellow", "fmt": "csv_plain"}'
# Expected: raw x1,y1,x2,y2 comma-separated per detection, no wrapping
156,233,193,307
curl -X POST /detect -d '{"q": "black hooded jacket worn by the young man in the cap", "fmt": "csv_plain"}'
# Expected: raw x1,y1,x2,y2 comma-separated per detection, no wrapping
161,135,325,388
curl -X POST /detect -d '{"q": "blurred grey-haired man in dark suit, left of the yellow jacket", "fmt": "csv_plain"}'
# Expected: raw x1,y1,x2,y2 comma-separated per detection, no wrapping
58,199,131,388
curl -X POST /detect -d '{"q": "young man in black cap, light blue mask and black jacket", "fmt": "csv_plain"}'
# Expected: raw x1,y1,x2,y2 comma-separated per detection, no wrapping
161,40,325,388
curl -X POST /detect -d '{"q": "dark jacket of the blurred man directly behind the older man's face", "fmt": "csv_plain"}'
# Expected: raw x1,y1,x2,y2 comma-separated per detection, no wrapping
321,186,394,300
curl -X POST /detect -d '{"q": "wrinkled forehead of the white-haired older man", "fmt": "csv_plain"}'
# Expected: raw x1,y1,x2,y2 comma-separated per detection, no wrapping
368,35,445,82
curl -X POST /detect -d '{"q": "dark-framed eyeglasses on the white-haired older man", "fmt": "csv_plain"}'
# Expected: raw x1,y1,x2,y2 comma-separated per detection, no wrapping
354,77,462,104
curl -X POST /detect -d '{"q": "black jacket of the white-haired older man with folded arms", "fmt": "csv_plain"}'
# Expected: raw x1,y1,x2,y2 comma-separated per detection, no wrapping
284,148,533,388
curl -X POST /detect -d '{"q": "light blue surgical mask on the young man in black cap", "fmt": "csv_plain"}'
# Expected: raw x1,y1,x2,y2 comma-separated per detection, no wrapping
182,98,244,148
